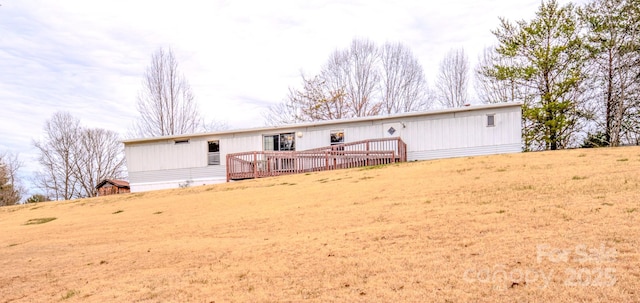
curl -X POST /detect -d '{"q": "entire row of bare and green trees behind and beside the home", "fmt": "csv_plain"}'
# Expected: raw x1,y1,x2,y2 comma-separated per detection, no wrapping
0,0,640,205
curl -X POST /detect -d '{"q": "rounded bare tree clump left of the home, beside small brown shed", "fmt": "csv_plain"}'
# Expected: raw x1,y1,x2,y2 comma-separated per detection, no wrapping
34,112,124,200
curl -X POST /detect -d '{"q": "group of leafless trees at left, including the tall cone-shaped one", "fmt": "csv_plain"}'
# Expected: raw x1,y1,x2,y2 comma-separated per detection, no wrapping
0,48,208,206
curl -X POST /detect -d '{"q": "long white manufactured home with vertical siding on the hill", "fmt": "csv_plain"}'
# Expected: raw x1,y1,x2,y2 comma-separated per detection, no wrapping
124,103,522,192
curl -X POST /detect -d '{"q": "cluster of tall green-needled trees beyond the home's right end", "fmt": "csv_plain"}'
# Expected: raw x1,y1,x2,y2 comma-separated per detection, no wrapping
477,0,640,150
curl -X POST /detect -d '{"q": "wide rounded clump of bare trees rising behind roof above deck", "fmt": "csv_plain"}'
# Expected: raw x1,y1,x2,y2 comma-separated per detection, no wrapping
265,39,432,125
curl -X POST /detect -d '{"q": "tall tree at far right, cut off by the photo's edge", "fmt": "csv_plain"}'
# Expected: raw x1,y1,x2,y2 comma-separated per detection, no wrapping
579,0,640,146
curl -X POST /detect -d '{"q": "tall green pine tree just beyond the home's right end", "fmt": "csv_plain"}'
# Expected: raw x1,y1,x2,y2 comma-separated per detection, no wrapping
491,0,587,150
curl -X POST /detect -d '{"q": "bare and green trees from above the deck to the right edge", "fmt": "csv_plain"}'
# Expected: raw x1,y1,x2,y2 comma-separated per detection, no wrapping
265,0,640,151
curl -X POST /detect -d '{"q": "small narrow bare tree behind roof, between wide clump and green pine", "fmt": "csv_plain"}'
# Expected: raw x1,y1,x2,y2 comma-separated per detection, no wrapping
436,48,469,107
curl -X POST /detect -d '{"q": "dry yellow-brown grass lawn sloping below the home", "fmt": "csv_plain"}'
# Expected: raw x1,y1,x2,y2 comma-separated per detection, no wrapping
0,147,640,302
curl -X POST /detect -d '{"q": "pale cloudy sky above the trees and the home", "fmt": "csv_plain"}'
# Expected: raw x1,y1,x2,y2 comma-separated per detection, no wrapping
0,0,584,189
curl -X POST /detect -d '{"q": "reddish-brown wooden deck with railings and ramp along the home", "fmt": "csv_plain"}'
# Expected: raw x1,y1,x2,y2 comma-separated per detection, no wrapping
226,138,407,182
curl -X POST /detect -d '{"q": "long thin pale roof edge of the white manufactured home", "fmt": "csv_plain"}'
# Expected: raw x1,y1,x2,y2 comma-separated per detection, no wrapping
122,102,523,145
